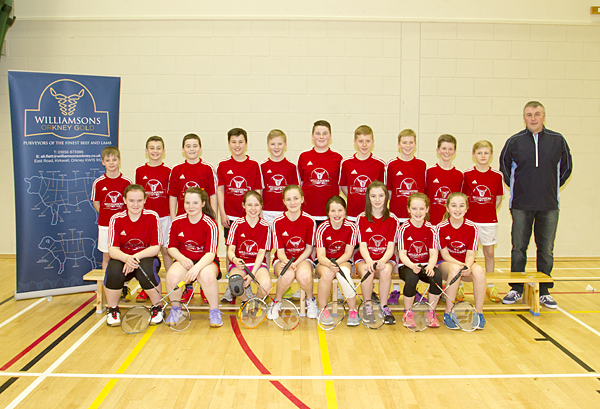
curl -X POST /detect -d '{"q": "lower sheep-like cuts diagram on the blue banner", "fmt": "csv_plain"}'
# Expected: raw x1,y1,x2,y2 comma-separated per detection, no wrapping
38,231,101,274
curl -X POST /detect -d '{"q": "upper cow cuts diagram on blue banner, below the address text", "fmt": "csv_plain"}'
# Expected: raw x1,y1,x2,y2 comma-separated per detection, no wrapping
25,173,97,226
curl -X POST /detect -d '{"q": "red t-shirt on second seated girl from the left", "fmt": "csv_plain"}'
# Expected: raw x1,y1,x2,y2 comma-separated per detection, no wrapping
168,214,219,262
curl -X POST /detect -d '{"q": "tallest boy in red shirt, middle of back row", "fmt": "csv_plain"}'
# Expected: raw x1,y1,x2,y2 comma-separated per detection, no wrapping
298,120,342,225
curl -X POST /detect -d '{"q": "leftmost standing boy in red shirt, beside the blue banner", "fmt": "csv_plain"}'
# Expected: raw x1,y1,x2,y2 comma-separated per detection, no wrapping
92,146,131,272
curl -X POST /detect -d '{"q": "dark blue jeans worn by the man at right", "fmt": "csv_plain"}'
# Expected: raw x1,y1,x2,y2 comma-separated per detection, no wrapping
510,209,559,295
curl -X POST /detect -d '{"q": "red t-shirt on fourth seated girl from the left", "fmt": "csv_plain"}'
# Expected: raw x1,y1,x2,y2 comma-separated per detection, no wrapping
273,212,316,259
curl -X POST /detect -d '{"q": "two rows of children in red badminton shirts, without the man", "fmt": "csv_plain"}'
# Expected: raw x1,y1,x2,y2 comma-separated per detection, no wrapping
92,121,503,329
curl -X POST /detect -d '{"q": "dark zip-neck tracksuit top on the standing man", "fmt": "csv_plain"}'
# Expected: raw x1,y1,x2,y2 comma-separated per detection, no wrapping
500,127,573,211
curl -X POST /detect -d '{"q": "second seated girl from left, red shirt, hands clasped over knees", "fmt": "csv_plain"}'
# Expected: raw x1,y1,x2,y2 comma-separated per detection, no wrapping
166,187,223,327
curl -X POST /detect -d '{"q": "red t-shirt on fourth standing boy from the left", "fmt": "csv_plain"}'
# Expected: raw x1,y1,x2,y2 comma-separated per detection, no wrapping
217,155,263,218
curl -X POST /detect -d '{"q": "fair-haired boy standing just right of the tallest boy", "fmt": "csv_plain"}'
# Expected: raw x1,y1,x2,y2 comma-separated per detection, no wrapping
339,125,385,221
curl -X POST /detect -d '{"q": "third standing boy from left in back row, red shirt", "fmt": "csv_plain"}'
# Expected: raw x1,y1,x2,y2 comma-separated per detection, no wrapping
169,133,217,304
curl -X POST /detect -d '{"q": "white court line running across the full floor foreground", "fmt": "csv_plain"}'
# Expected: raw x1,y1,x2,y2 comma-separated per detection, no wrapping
0,372,600,381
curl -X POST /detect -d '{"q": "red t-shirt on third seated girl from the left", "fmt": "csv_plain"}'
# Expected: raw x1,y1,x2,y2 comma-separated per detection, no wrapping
225,217,271,264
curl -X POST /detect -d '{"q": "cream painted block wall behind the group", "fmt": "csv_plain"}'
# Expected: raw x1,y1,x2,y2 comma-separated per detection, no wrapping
0,1,600,256
